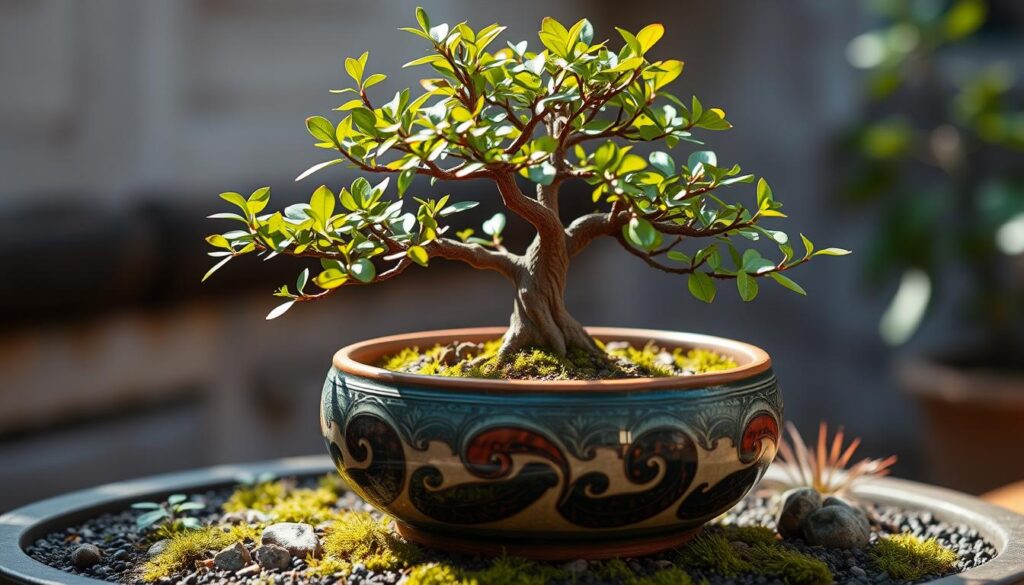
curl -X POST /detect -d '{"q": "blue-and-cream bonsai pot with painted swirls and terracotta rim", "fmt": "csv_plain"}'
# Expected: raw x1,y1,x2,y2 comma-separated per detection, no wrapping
322,328,782,559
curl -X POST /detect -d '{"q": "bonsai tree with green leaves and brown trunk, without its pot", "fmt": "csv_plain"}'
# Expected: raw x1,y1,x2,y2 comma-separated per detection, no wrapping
204,8,848,357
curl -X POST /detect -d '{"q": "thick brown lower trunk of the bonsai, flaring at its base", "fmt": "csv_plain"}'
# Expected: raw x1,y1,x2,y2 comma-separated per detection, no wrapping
501,232,602,357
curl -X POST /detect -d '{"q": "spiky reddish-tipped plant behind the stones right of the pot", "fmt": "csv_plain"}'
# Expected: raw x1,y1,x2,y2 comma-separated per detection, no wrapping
776,422,896,496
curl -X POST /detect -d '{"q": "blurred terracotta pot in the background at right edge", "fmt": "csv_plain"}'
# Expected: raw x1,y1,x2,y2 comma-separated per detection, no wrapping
898,358,1024,494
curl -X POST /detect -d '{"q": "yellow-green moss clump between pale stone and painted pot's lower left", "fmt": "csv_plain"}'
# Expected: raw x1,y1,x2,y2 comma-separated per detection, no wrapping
324,512,421,571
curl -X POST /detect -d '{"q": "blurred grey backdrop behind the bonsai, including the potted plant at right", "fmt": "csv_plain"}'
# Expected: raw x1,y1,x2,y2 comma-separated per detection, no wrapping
0,0,1024,510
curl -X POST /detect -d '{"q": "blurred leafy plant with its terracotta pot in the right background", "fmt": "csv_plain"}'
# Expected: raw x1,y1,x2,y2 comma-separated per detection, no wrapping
847,0,1024,493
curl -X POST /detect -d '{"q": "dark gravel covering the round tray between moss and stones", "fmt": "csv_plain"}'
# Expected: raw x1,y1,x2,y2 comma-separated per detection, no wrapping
27,479,996,585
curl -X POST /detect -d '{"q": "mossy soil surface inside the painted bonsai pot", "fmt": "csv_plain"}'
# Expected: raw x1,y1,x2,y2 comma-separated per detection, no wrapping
378,339,736,380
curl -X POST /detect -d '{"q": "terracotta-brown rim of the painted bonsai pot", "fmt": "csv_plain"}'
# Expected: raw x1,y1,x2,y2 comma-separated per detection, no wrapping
334,327,771,392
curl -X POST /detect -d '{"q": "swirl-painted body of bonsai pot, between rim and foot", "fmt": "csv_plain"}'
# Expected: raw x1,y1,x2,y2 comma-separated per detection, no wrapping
322,369,782,539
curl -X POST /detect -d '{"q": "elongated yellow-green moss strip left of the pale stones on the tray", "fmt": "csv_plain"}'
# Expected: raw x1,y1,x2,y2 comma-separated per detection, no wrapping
140,525,260,581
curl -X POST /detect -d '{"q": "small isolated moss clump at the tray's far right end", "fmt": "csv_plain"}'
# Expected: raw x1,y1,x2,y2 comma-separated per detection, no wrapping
868,534,956,581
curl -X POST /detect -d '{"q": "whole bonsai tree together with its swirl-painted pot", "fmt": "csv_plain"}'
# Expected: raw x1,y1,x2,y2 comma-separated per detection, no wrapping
201,9,847,558
